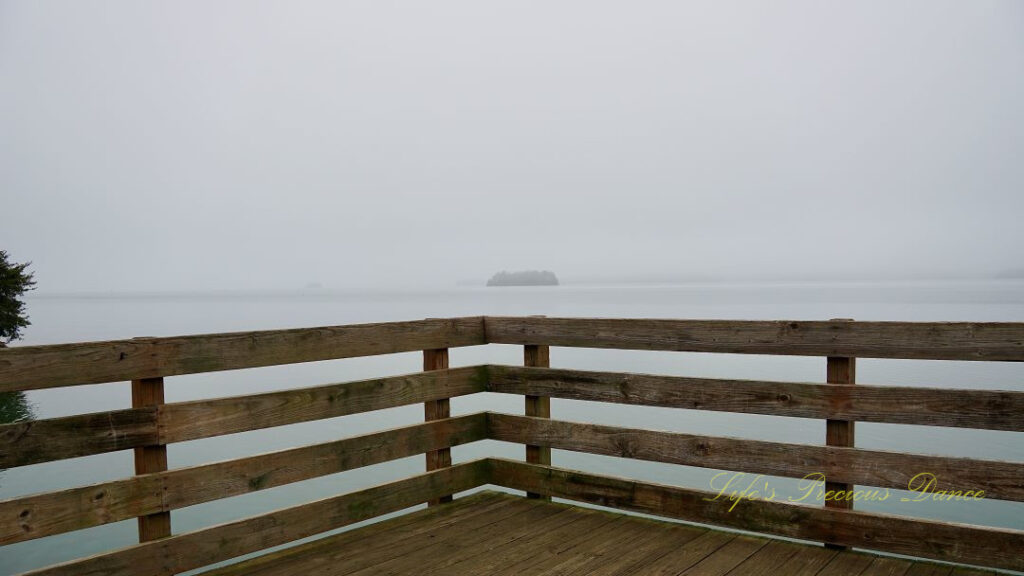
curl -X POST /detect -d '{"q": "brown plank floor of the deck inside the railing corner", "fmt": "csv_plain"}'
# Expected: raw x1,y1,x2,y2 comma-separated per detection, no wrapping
205,491,994,576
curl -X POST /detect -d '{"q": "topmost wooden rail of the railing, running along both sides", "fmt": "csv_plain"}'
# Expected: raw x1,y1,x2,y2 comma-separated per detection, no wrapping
0,316,1024,392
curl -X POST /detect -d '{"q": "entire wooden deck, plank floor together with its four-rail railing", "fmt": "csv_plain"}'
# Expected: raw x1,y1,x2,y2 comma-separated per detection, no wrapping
0,317,1024,576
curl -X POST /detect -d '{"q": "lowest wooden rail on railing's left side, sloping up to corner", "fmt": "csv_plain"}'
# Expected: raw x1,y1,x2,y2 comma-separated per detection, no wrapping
19,460,489,576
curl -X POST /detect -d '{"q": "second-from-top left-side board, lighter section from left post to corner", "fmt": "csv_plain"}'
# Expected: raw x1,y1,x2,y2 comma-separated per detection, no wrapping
161,367,486,444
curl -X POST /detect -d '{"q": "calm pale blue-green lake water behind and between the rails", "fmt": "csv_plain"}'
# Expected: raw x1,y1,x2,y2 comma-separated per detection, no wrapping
0,281,1024,574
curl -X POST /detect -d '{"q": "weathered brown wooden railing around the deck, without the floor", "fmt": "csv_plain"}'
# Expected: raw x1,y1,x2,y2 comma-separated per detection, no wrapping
0,317,1024,575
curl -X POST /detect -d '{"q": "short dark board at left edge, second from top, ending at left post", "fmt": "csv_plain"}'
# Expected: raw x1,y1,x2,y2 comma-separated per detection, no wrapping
0,407,160,468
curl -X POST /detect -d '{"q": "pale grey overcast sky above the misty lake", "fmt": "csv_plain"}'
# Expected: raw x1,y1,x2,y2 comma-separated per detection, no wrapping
0,0,1024,291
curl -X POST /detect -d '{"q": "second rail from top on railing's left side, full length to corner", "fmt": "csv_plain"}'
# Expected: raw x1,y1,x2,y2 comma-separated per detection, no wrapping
0,367,486,468
